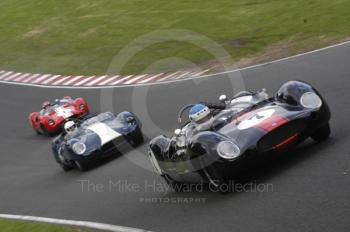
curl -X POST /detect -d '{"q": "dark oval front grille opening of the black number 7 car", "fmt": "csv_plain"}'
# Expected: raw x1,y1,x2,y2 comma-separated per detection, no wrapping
257,120,306,152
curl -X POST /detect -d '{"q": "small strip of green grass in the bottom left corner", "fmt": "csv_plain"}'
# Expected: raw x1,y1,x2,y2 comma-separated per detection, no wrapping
0,220,87,232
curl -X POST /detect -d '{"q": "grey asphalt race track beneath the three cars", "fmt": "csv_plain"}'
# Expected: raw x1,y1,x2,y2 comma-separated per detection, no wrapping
0,45,350,232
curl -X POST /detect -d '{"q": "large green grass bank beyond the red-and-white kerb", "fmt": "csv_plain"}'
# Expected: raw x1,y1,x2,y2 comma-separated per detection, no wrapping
0,0,350,75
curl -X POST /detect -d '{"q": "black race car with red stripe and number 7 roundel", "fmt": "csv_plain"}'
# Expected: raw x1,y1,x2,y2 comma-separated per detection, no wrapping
148,81,331,192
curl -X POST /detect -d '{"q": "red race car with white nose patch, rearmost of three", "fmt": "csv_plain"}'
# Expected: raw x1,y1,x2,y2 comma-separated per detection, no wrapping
29,96,89,136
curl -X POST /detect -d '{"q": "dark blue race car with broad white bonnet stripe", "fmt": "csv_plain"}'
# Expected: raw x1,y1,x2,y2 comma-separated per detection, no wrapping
52,111,143,171
